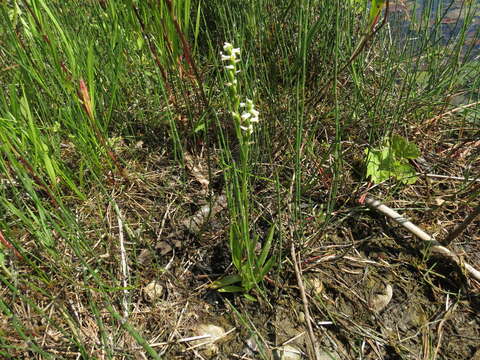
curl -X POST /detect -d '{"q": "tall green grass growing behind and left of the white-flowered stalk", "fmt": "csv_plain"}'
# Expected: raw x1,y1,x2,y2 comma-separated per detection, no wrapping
0,0,479,358
